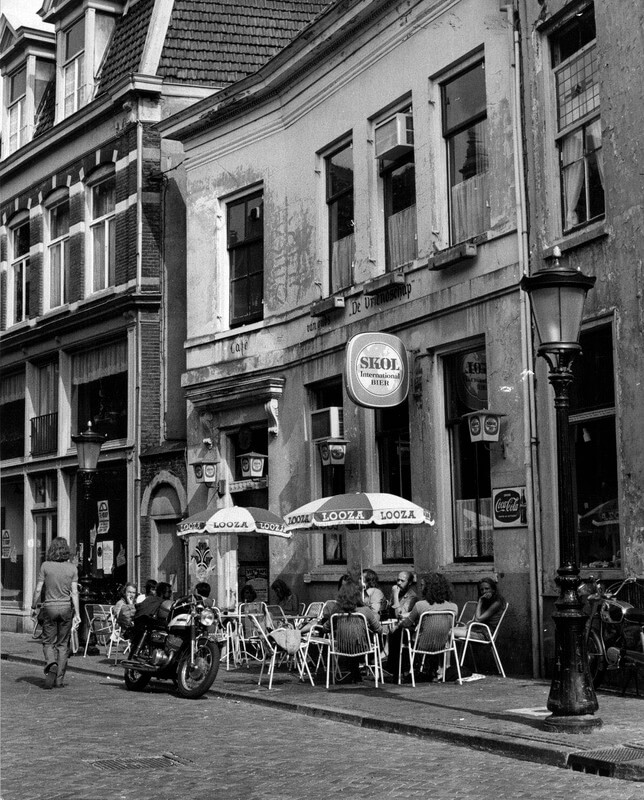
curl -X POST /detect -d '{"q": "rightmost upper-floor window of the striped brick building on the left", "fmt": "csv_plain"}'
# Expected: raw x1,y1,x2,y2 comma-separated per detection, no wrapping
90,175,116,292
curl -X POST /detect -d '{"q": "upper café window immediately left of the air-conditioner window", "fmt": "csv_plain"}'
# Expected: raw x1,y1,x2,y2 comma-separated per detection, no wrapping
326,143,355,292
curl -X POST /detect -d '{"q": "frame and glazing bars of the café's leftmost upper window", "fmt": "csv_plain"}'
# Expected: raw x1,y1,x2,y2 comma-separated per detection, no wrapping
226,186,266,329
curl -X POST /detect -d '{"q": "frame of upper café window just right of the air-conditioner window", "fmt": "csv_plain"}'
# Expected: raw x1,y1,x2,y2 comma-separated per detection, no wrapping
439,58,490,245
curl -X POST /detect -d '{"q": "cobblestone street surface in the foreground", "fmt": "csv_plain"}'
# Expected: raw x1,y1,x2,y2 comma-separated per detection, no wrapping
2,662,642,800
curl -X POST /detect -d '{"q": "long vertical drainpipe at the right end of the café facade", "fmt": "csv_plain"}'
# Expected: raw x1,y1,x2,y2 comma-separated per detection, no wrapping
503,0,543,677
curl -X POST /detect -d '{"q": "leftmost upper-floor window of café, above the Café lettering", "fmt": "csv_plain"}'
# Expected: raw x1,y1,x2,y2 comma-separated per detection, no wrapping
228,192,264,328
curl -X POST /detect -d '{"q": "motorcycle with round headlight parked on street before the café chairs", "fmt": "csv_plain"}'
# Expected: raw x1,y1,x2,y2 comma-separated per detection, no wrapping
121,596,220,699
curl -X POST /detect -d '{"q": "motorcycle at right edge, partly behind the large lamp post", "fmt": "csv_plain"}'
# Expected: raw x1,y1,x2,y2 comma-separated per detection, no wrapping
577,577,644,691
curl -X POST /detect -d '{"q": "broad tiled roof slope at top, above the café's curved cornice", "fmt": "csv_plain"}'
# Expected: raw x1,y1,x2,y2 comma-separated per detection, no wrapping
158,0,331,86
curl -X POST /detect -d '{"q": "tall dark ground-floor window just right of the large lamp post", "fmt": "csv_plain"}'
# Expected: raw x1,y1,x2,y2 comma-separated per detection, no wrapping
570,325,621,569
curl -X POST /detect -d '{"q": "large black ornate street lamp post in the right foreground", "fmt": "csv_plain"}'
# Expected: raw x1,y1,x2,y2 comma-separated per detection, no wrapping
521,248,602,732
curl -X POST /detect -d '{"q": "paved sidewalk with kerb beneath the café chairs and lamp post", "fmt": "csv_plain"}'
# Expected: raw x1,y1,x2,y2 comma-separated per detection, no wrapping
0,633,644,781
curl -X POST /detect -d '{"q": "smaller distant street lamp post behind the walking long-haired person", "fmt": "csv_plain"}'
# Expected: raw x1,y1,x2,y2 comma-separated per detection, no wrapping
72,422,105,652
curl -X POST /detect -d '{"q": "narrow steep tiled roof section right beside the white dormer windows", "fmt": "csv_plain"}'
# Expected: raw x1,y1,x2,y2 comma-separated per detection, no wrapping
98,0,154,94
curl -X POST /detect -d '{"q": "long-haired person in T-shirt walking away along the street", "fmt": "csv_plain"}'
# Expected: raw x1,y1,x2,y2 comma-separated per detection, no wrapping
31,536,80,689
